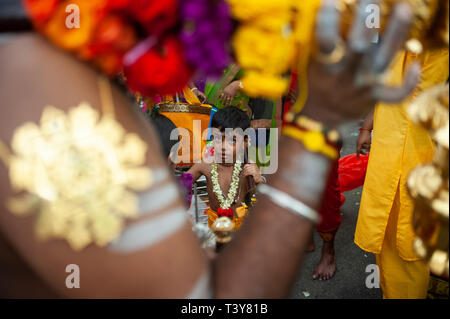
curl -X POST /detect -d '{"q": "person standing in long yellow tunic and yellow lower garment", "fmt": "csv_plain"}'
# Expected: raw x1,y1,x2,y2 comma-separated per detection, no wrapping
355,50,449,299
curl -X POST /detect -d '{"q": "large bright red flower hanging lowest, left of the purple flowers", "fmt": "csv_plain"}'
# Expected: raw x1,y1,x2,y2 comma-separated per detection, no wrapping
124,36,192,96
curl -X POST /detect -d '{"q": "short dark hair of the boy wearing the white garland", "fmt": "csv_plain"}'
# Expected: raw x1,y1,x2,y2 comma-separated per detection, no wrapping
211,106,250,132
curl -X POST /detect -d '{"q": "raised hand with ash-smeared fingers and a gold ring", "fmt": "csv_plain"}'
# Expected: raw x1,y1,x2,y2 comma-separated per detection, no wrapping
303,0,421,126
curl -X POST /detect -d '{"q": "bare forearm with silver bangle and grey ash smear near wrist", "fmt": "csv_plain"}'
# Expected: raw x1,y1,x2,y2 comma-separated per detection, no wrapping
213,138,331,298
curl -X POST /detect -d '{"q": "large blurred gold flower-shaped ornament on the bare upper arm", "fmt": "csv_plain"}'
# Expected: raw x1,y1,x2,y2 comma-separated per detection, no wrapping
0,103,152,251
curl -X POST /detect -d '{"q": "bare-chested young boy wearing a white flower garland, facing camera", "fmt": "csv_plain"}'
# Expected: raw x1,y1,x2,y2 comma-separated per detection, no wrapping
188,107,264,230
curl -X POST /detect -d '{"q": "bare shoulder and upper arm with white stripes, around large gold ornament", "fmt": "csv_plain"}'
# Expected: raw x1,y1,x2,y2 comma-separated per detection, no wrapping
0,34,207,298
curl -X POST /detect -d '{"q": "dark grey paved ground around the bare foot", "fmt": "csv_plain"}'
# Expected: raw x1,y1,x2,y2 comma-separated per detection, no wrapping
290,125,382,299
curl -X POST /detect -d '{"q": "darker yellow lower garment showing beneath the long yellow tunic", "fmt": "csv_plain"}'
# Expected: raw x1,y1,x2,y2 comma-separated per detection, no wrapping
376,185,430,299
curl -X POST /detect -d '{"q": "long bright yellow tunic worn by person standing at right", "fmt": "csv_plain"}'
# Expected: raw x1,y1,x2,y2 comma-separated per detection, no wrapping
355,50,449,261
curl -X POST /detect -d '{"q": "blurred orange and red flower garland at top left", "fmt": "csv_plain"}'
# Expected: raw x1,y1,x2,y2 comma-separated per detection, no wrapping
24,0,192,96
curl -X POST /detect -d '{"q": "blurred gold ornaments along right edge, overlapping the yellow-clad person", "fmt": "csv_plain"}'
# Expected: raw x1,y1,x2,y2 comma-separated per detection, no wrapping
407,85,449,277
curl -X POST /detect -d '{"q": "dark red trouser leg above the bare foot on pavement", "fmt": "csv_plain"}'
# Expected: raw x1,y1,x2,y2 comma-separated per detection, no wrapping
317,149,343,233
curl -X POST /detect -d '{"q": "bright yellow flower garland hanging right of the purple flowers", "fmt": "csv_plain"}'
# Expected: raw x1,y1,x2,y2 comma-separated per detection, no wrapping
228,0,296,99
